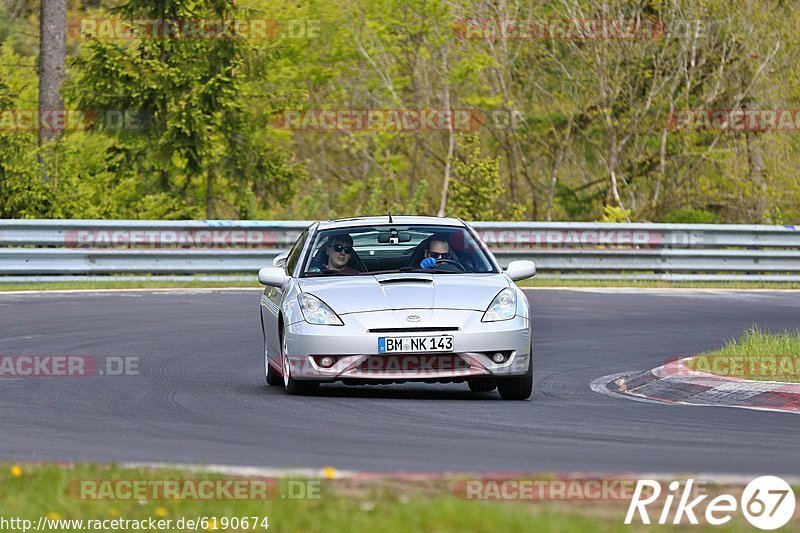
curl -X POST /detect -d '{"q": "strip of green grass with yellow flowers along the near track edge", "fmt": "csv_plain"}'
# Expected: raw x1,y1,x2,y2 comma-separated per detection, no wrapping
0,464,756,533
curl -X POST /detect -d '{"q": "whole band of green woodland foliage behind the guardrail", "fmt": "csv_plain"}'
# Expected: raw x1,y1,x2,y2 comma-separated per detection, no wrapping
0,0,800,220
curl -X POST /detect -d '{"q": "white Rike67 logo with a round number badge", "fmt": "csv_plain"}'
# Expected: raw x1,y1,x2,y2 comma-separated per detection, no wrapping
625,476,795,530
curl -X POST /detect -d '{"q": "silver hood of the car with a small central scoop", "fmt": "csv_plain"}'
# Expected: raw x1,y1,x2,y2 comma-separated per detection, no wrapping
300,273,510,315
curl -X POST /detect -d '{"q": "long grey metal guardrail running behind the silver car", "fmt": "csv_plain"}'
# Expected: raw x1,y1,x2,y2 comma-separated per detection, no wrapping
0,220,800,281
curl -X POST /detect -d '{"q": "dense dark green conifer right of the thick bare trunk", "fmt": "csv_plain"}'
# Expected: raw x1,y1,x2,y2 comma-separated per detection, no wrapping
69,0,302,218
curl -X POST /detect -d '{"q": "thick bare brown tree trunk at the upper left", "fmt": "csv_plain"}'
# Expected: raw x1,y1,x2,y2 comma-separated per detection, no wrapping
39,0,67,150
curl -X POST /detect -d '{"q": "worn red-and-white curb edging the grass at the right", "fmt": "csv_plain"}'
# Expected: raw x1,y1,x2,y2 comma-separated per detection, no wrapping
591,357,800,414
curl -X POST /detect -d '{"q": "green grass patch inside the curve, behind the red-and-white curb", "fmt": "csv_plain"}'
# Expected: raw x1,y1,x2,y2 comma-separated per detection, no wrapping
686,327,800,383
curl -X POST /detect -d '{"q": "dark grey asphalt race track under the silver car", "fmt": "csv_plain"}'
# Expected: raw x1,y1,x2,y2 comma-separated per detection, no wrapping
0,290,800,476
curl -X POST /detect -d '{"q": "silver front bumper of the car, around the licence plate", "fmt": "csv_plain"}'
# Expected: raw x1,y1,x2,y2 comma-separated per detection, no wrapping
285,309,532,383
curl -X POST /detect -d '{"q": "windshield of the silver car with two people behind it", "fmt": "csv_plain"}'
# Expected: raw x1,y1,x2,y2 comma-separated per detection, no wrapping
301,224,498,277
